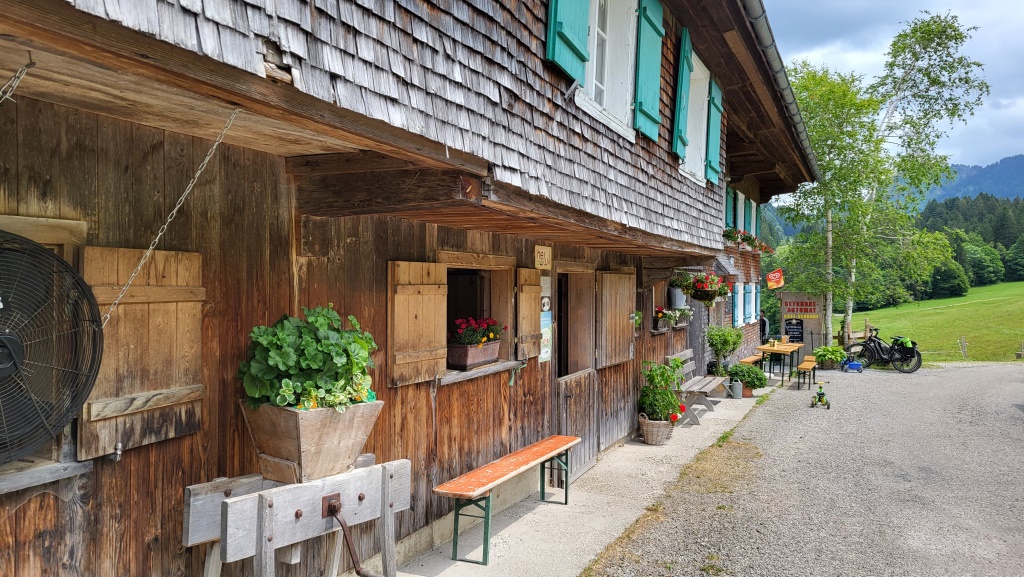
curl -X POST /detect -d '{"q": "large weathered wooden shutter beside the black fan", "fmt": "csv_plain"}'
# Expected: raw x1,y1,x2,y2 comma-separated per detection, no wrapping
78,246,206,461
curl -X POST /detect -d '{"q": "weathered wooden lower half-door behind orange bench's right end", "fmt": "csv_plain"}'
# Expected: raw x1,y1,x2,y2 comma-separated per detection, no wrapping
558,369,600,483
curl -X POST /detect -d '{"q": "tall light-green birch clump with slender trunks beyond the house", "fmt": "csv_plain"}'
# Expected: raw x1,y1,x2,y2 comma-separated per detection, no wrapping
781,11,989,344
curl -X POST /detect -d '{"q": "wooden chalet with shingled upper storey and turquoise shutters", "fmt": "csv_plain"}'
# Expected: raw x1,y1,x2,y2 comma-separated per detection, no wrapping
0,0,816,577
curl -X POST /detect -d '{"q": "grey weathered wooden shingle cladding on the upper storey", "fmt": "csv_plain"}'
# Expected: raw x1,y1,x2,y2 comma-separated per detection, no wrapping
68,0,729,249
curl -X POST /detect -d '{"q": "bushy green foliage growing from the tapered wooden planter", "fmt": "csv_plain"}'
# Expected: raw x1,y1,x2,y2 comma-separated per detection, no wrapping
239,303,377,412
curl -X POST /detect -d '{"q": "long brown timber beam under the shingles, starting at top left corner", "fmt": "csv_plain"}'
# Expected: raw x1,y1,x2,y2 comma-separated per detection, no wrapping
0,0,488,176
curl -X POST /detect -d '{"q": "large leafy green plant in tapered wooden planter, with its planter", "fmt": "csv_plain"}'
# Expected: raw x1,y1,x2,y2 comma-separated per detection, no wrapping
239,303,384,483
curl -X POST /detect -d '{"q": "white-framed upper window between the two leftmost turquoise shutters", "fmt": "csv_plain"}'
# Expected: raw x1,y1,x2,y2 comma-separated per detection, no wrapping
575,0,637,140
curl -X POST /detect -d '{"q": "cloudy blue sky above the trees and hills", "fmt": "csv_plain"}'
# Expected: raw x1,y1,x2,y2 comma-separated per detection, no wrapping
763,0,1024,165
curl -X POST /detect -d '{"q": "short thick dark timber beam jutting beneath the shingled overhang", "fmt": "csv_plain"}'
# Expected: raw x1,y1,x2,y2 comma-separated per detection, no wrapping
295,170,482,216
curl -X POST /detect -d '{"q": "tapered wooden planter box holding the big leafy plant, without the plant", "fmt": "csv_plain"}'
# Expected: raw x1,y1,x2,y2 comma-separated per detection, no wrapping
240,401,384,484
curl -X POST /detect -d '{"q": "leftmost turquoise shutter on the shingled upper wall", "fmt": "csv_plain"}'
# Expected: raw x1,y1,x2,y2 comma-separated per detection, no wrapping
546,0,590,84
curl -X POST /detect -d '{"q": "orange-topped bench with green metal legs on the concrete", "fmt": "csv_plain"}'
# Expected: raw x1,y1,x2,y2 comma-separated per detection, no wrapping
434,435,581,565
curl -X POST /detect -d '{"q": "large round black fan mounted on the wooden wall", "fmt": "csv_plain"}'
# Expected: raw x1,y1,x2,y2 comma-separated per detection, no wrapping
0,231,103,463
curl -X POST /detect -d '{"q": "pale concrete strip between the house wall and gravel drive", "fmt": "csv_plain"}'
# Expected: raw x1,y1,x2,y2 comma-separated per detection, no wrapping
385,387,773,577
